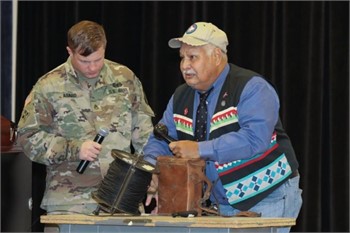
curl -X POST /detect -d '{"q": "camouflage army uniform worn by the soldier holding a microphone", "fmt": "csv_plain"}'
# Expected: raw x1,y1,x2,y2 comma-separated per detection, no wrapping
18,58,154,213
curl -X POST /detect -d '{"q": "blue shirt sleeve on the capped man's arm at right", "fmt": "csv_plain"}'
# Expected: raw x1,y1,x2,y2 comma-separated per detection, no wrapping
199,77,279,163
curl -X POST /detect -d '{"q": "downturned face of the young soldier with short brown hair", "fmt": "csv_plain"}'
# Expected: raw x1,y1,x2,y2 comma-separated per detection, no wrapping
67,47,105,78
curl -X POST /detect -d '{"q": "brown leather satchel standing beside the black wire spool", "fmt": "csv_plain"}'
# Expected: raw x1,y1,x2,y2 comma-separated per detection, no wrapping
157,156,211,216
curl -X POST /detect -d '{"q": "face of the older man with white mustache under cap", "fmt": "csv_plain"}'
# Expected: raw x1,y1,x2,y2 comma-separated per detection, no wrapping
180,43,217,91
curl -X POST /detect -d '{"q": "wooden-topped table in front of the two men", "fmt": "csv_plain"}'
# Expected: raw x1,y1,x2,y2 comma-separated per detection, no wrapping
41,214,295,233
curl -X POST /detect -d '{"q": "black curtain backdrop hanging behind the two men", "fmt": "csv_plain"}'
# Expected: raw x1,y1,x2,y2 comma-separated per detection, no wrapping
9,1,349,232
